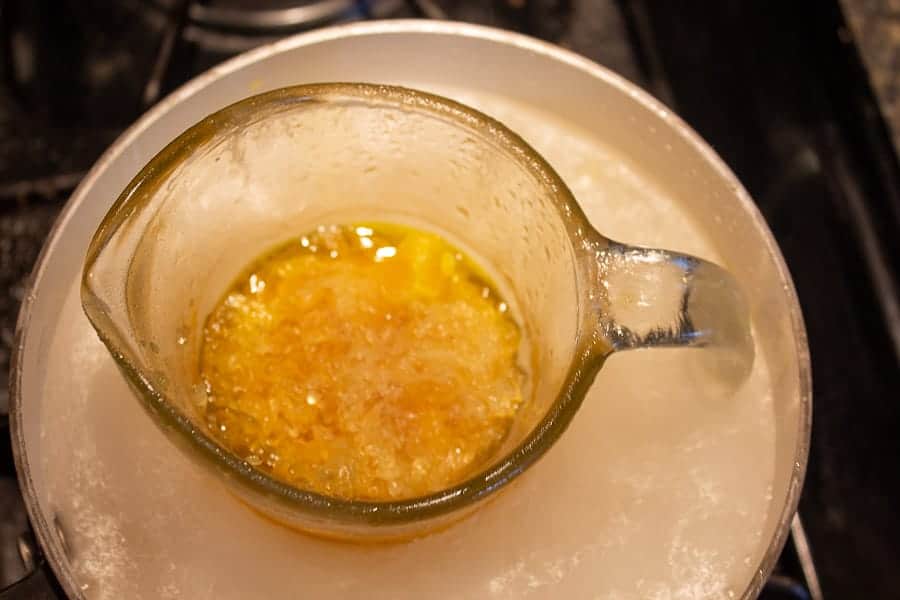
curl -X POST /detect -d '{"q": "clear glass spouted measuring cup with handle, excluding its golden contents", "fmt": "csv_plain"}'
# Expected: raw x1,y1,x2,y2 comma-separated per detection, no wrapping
82,84,752,539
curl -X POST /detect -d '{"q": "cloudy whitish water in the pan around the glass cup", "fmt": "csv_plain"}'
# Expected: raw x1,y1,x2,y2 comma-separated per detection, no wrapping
37,91,774,600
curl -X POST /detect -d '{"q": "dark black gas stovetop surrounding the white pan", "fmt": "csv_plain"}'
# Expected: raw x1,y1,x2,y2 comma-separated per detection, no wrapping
0,0,900,600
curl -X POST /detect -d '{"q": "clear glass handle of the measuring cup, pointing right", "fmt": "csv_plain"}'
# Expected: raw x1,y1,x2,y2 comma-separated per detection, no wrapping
593,242,754,379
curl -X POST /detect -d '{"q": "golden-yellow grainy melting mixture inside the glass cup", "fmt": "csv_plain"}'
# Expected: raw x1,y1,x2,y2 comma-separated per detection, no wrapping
200,224,524,500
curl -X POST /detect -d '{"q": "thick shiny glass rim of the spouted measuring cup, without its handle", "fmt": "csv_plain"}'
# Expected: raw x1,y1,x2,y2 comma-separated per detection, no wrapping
81,82,605,526
